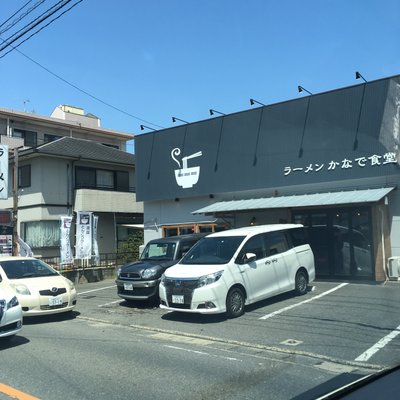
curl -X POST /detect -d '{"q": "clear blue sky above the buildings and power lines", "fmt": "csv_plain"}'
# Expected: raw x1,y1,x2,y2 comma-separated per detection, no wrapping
0,0,400,150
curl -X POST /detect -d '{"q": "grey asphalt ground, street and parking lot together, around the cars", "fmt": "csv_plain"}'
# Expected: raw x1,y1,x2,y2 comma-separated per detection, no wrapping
0,280,400,400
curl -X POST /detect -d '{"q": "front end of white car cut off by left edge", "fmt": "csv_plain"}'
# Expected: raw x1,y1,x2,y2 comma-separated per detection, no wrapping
0,286,22,338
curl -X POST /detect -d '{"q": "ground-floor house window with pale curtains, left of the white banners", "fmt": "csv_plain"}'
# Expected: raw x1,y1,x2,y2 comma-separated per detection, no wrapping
21,221,60,248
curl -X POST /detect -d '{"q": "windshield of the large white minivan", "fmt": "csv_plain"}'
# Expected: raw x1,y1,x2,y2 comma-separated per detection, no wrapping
181,236,245,264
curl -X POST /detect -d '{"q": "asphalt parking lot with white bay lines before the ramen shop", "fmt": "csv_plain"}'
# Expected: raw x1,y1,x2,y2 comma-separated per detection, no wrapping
77,280,400,366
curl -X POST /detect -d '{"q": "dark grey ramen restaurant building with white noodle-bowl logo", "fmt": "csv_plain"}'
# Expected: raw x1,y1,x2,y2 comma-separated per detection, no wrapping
135,76,400,280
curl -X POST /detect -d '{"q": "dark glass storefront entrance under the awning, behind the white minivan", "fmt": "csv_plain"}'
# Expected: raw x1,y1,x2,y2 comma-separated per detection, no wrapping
292,207,374,279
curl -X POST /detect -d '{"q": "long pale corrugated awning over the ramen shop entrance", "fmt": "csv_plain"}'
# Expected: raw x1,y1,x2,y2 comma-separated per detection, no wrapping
192,187,394,214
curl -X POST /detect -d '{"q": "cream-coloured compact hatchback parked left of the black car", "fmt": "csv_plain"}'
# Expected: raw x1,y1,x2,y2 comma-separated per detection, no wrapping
0,257,77,317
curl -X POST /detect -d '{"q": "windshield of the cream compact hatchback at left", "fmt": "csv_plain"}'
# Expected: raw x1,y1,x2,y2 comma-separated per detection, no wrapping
0,260,58,279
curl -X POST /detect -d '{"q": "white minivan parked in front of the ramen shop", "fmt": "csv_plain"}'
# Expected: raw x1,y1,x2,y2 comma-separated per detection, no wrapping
159,224,315,318
